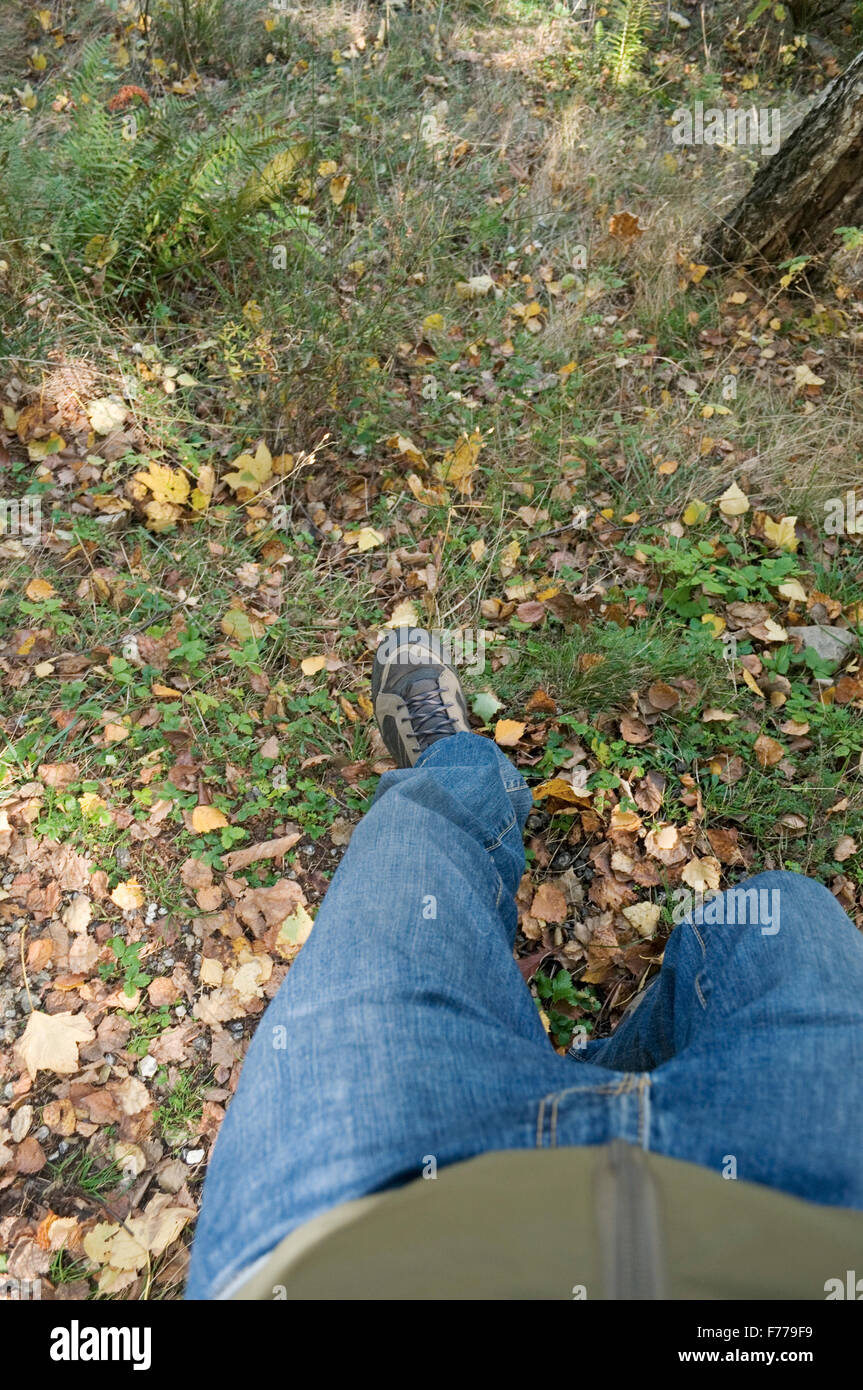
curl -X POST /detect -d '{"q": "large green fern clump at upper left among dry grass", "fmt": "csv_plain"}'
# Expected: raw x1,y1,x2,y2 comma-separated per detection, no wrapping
0,52,300,307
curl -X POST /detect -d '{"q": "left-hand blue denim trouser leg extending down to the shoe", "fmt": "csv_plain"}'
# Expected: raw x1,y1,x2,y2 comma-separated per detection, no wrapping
188,734,639,1297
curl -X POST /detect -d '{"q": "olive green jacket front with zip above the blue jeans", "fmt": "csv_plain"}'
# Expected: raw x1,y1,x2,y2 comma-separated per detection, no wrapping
228,1141,863,1300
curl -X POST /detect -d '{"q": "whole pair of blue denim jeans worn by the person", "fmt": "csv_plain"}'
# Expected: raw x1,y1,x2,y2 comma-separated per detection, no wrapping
188,734,863,1298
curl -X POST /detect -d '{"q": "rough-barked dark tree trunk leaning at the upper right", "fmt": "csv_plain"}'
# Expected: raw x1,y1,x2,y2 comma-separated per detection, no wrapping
702,53,863,265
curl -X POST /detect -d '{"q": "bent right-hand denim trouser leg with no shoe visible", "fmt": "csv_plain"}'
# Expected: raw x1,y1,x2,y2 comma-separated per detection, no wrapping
578,872,863,1208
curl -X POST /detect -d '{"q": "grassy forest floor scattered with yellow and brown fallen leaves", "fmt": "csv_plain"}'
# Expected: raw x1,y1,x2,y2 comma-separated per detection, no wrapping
0,0,863,1298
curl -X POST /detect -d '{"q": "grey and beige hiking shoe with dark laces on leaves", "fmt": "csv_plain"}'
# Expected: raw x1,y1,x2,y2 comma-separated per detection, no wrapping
371,627,470,767
